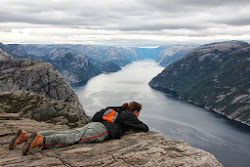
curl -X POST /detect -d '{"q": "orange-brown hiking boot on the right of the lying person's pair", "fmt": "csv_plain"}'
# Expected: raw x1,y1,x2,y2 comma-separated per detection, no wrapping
23,132,44,155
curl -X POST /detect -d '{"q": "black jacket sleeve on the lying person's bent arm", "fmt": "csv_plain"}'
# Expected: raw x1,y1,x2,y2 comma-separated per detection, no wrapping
122,115,149,132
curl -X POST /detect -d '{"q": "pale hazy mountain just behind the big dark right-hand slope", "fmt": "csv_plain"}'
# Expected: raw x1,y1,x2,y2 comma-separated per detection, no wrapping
156,45,195,67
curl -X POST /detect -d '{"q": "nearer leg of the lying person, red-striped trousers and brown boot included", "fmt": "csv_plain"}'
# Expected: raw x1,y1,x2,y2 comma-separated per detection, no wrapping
23,122,108,155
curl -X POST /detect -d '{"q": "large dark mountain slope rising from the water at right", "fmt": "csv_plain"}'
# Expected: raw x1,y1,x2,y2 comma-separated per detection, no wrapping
149,41,250,125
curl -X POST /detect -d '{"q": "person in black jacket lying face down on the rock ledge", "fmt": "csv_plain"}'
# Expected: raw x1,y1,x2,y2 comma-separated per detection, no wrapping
9,101,148,155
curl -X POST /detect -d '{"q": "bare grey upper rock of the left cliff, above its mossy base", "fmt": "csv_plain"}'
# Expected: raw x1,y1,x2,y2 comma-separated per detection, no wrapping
0,59,84,114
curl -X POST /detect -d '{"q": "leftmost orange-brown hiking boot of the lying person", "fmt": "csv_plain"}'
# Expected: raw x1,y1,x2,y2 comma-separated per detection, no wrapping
9,129,29,150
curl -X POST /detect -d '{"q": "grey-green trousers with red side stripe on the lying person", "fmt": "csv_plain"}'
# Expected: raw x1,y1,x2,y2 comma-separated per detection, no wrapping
38,122,108,148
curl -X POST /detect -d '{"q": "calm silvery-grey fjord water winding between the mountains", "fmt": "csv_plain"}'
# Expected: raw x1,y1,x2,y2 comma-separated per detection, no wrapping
73,60,250,167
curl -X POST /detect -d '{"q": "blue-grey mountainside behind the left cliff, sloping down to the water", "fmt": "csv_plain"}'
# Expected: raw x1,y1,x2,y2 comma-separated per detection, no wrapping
1,44,98,84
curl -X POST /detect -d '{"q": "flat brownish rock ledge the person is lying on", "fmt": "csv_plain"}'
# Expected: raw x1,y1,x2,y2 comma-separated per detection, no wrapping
0,113,222,167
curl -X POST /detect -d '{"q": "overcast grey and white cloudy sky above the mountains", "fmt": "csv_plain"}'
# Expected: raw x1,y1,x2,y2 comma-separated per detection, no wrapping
0,0,250,47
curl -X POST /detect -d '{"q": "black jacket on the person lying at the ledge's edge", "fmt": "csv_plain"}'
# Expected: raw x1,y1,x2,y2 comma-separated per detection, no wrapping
92,107,148,139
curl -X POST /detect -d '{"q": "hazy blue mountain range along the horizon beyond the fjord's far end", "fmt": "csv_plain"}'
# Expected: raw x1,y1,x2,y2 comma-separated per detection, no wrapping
24,44,194,67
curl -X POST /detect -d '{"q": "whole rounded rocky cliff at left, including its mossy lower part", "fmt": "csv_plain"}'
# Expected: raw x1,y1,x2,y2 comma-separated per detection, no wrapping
0,59,89,126
